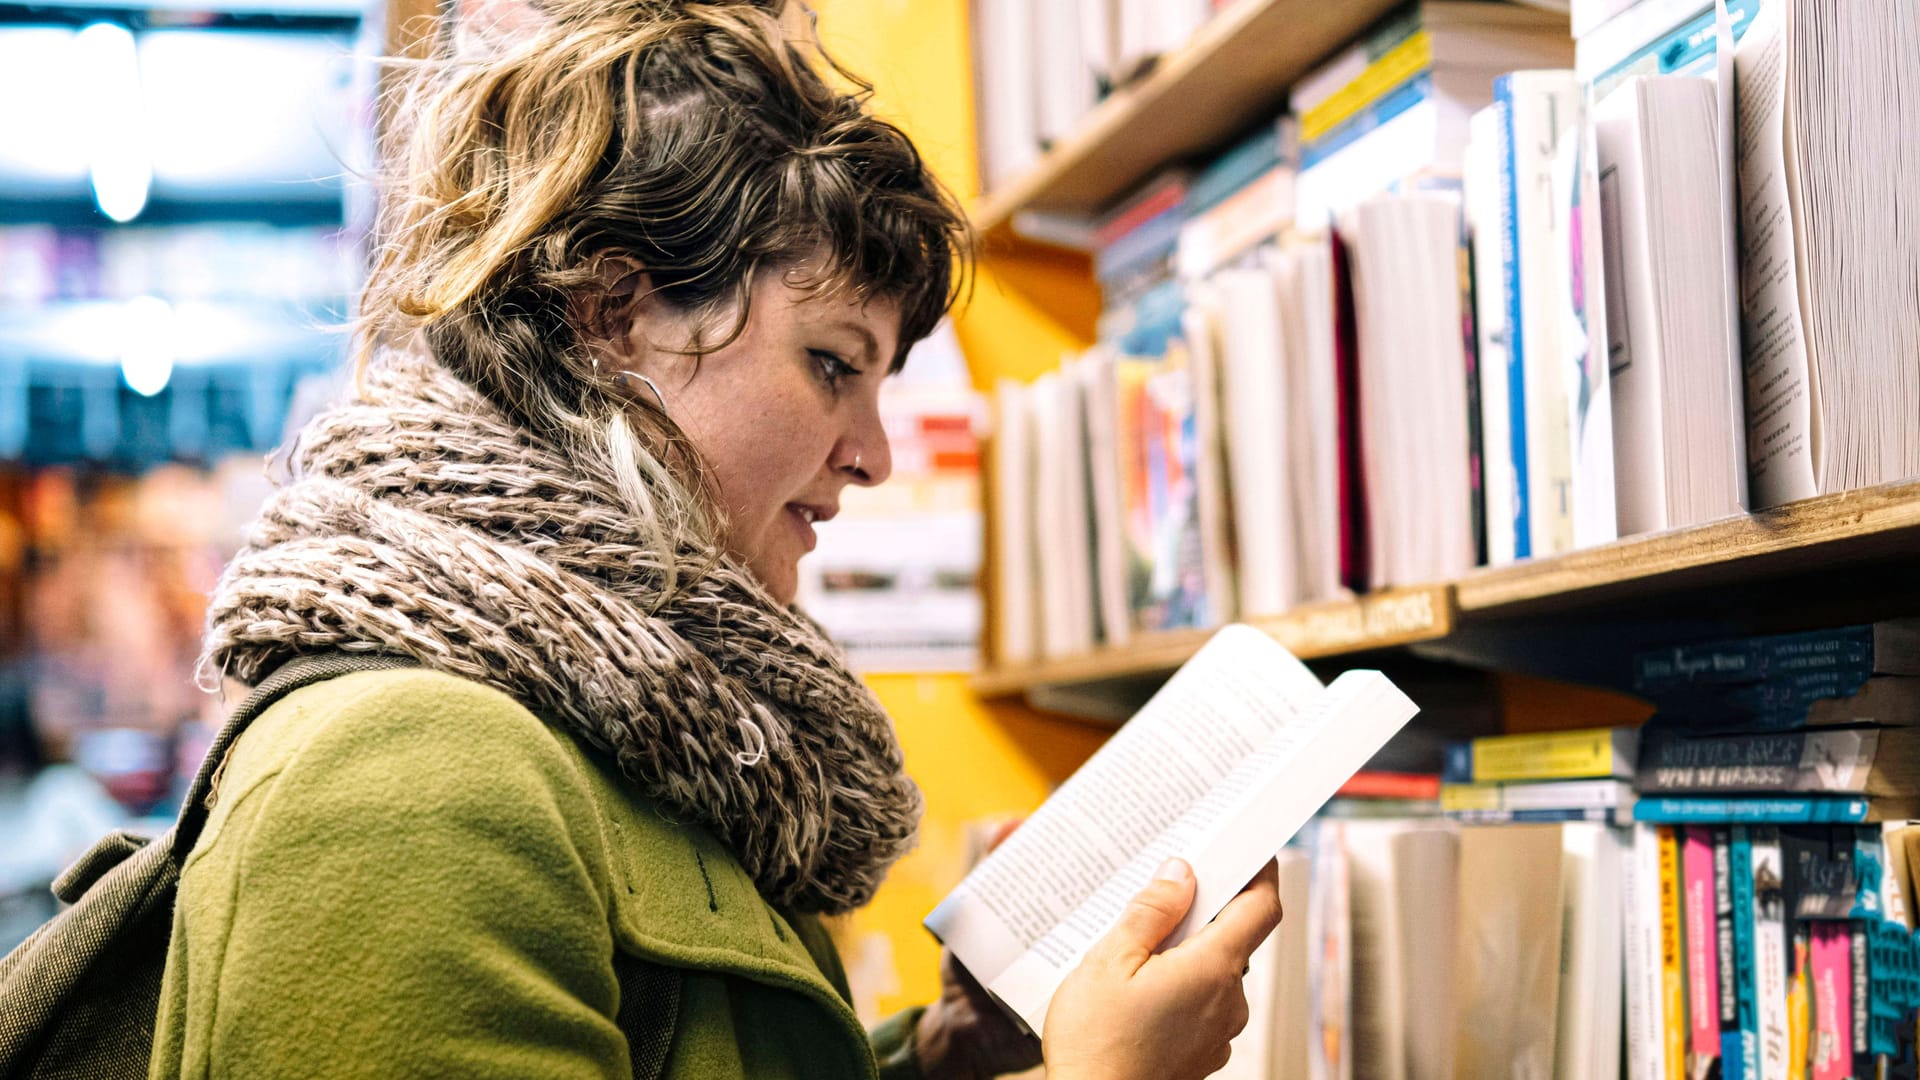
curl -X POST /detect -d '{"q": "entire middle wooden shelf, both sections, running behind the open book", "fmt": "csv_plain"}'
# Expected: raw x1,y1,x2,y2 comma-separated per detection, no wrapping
973,480,1920,698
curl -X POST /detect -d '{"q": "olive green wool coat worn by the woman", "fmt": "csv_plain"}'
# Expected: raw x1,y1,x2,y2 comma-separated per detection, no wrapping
150,669,918,1080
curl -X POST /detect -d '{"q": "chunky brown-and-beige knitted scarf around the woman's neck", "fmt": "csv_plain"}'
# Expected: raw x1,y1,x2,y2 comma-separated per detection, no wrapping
204,354,920,913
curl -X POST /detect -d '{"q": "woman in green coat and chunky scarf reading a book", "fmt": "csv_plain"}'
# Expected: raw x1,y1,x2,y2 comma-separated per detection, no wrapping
152,0,1279,1078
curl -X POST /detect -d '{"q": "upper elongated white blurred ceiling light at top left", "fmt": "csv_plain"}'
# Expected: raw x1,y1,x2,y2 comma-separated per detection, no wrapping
73,23,151,222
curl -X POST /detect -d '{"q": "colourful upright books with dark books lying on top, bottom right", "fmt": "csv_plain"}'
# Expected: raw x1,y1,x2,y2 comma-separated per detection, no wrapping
1626,621,1920,1076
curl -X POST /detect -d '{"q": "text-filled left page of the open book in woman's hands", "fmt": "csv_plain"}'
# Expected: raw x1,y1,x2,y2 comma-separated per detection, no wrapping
925,626,1321,986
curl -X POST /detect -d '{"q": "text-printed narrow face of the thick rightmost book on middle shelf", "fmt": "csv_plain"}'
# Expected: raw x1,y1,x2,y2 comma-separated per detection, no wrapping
1734,4,1818,509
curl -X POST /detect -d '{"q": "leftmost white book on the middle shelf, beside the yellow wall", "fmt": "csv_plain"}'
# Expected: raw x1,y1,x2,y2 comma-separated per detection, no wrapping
993,379,1039,665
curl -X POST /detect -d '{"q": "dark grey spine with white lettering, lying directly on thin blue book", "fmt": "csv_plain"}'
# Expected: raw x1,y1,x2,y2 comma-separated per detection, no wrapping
1636,730,1880,794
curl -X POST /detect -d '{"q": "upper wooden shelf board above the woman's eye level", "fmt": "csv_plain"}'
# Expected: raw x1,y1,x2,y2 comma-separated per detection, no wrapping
973,0,1396,233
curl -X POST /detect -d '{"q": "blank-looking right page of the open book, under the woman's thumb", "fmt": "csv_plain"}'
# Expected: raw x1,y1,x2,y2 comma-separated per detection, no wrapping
962,671,1417,1032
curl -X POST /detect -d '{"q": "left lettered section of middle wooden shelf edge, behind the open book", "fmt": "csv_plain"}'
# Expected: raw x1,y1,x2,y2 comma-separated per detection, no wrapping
970,584,1457,698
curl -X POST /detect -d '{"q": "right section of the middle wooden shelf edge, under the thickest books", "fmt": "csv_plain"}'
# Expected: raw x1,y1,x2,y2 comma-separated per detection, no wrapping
1455,480,1920,613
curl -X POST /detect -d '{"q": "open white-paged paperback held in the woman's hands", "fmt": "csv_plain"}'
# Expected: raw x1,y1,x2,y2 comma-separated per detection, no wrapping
925,626,1417,1034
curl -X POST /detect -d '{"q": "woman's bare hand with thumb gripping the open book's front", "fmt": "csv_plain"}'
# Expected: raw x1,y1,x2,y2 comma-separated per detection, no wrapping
1046,859,1281,1080
